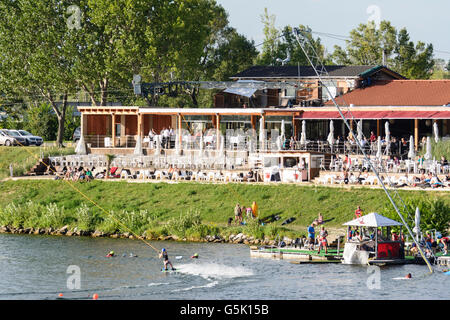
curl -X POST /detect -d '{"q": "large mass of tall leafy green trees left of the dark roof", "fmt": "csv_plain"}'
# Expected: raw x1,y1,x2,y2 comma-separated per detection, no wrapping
0,0,255,116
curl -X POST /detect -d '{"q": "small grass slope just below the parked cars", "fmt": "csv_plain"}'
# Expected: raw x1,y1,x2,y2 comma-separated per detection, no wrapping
0,147,74,179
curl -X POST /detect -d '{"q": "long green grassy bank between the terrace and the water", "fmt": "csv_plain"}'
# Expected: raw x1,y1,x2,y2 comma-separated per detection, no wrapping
0,180,450,238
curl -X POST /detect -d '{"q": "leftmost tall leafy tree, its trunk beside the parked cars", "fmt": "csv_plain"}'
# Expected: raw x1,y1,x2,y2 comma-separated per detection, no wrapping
0,0,75,146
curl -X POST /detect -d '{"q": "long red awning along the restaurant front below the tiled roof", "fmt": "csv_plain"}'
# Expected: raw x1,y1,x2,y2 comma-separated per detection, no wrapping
295,109,450,120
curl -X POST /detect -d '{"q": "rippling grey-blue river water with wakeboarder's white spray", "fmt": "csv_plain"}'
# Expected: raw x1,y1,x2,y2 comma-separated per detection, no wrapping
0,234,450,300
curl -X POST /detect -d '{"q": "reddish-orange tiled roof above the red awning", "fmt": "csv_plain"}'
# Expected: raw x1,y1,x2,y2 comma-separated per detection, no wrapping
325,80,450,106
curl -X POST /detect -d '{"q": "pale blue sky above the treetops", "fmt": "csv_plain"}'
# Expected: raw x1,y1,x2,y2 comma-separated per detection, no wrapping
216,0,450,61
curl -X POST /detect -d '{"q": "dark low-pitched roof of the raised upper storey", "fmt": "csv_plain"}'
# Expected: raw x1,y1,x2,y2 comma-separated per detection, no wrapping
231,65,404,79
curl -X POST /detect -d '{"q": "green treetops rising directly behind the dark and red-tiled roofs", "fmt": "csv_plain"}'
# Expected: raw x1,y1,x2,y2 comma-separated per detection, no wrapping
332,21,434,79
